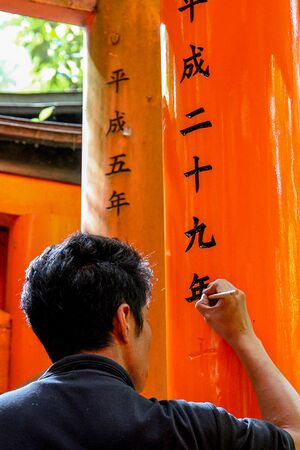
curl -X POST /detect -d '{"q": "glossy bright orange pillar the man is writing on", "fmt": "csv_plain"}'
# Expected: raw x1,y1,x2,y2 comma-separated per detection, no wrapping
161,0,300,416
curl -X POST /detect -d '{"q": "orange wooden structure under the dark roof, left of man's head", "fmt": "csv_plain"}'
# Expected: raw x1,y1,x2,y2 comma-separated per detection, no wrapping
0,174,81,389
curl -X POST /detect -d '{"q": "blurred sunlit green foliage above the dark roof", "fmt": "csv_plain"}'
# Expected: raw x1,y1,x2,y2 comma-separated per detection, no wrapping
9,16,83,91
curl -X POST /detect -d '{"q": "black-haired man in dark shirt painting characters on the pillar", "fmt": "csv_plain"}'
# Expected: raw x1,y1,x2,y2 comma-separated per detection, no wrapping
0,233,300,450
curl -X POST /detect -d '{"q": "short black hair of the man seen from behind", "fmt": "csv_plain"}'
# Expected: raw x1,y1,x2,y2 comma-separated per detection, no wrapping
21,232,152,361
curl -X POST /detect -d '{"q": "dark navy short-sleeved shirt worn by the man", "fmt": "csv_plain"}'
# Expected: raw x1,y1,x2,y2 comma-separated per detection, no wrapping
0,355,295,450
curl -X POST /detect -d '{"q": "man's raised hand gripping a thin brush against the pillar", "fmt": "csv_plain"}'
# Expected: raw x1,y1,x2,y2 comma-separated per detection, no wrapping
195,279,254,347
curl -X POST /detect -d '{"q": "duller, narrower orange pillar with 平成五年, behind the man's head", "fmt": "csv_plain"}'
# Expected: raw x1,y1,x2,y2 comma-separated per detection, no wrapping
82,0,166,397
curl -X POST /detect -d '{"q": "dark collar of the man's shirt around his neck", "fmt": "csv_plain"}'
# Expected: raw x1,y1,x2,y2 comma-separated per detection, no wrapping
39,353,135,389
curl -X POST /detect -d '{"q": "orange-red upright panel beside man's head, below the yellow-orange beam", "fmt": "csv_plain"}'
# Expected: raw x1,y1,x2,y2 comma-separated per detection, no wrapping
6,214,80,388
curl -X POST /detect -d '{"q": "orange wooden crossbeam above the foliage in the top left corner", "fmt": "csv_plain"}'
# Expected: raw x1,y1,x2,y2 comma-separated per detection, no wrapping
0,0,96,26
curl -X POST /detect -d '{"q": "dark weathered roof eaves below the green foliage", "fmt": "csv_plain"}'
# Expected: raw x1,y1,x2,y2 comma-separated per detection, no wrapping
0,92,82,184
